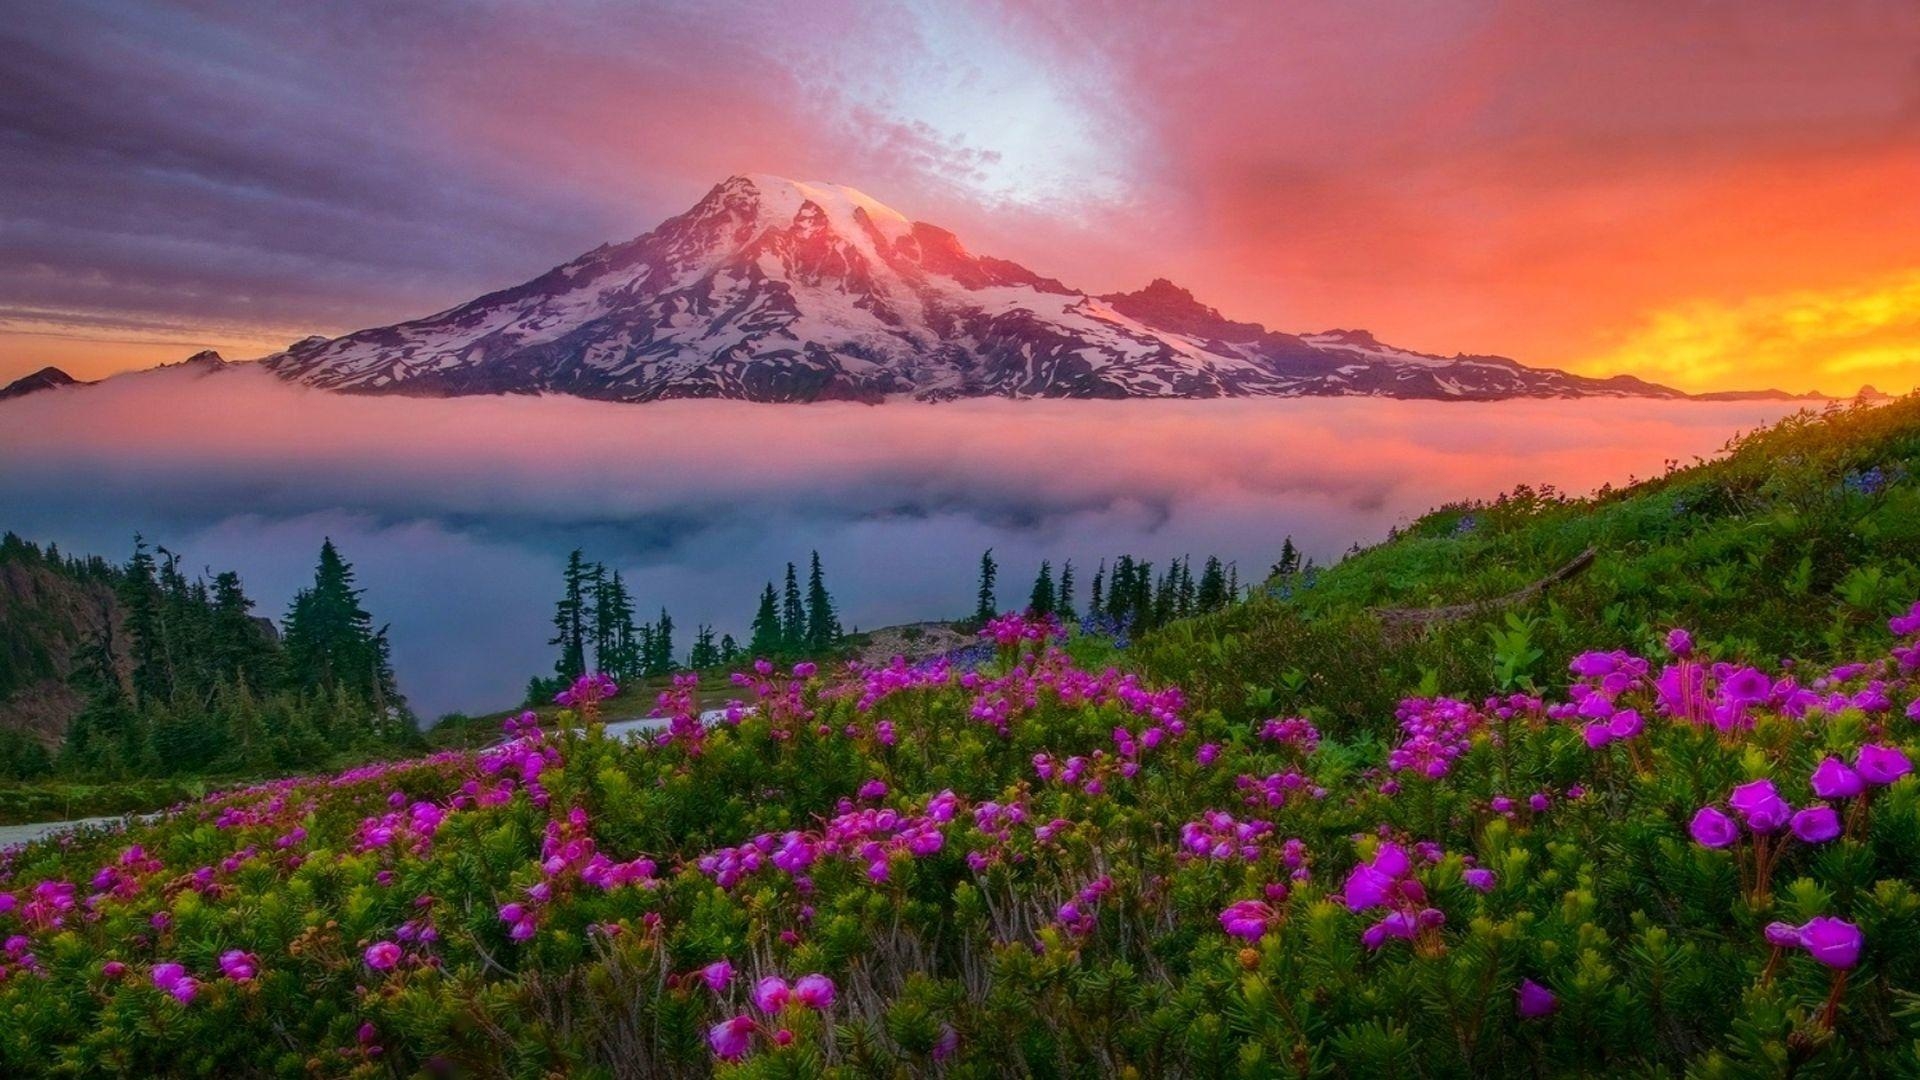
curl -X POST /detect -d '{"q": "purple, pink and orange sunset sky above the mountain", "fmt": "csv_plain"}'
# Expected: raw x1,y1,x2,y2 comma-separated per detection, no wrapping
0,0,1920,392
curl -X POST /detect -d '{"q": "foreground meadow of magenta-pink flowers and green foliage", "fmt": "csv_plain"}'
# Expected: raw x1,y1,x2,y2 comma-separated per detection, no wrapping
0,603,1920,1076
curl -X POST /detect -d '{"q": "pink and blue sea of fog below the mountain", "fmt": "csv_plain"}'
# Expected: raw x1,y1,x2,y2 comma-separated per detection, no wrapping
0,367,1791,717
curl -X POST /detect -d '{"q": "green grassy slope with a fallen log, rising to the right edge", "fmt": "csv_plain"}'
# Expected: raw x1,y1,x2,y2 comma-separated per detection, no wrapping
1129,396,1920,730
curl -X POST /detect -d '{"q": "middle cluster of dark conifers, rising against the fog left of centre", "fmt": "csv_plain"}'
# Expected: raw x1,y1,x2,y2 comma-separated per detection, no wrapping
528,550,847,703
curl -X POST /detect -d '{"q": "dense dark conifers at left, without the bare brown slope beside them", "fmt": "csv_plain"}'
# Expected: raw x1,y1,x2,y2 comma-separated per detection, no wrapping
0,534,419,778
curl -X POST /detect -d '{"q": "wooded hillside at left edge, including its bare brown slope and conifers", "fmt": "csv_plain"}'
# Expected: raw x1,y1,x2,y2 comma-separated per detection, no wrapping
0,532,413,778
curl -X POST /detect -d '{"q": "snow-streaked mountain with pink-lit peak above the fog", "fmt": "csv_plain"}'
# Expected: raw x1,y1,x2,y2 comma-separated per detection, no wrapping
265,175,1684,402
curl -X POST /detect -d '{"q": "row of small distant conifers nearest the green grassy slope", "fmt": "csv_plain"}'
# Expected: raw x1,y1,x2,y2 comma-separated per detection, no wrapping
972,536,1274,630
